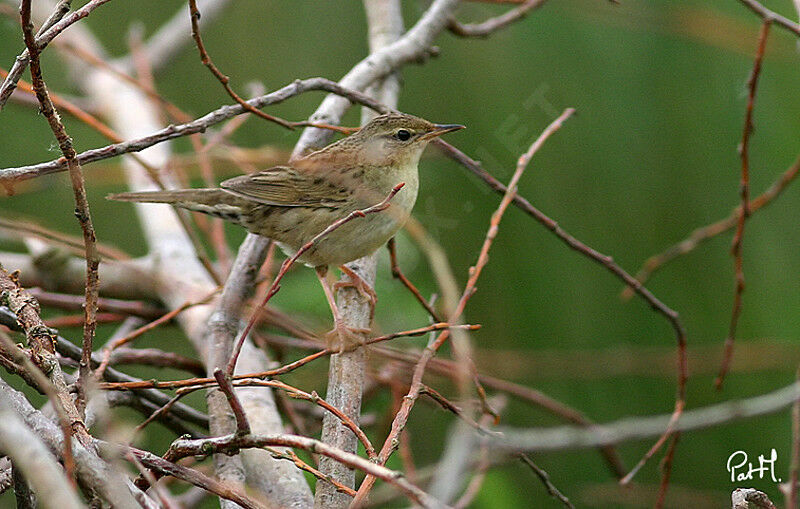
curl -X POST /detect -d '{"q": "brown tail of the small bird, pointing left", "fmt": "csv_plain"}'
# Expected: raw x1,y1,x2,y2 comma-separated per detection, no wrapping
106,189,247,222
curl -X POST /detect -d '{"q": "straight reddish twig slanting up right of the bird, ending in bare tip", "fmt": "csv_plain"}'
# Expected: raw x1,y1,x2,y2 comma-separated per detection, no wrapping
353,108,575,507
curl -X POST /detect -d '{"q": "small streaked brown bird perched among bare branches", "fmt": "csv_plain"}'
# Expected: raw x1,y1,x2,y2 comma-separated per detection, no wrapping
108,113,464,349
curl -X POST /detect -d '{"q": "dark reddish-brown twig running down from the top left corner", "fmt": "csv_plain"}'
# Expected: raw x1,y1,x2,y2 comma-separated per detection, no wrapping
20,0,100,413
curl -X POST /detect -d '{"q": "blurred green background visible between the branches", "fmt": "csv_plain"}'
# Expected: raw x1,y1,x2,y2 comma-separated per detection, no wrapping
0,0,800,508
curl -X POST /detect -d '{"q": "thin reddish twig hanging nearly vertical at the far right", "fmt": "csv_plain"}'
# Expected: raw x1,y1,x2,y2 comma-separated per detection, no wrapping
714,18,772,390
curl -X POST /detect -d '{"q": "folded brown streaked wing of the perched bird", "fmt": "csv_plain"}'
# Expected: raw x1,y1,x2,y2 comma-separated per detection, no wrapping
220,166,346,208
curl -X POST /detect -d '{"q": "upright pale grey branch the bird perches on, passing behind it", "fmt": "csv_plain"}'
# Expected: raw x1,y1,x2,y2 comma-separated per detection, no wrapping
315,0,403,508
